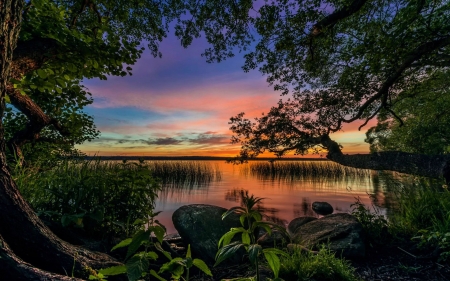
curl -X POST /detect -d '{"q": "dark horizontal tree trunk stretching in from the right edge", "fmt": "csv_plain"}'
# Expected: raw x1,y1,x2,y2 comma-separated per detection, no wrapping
321,135,450,184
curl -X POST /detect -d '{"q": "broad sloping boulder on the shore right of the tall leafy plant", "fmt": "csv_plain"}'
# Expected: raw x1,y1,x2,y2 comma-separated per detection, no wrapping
293,213,366,258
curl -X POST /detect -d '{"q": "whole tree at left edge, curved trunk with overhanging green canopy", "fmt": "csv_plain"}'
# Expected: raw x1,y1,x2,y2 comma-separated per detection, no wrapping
0,0,188,280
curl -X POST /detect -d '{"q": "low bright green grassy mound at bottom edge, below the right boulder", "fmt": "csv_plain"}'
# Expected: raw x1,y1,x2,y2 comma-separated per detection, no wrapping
280,246,360,281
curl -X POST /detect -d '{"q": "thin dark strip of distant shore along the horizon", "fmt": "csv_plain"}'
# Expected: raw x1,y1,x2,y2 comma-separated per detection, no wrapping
85,156,329,161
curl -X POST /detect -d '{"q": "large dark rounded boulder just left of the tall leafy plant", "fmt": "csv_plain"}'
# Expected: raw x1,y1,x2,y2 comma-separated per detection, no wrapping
172,204,243,264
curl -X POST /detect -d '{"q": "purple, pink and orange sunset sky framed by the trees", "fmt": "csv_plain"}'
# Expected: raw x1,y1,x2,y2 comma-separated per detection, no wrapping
77,34,371,157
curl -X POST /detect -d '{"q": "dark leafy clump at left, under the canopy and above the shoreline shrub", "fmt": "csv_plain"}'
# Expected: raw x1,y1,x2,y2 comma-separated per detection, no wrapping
3,80,99,164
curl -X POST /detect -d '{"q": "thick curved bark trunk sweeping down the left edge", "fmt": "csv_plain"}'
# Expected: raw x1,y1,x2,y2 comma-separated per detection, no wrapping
0,0,119,280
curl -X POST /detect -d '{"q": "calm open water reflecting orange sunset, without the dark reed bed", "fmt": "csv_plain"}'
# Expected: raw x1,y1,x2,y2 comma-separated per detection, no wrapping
156,161,385,233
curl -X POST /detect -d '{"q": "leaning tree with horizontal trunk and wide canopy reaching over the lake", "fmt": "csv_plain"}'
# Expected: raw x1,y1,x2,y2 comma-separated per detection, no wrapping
175,0,450,181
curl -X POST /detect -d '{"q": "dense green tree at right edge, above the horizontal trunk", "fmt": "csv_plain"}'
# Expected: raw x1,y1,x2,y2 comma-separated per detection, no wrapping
366,69,450,155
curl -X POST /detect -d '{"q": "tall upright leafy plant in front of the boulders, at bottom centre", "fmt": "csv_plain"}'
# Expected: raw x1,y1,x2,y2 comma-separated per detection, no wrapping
214,191,288,281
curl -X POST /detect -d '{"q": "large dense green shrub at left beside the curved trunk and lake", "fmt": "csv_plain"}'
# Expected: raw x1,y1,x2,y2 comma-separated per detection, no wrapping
13,160,160,238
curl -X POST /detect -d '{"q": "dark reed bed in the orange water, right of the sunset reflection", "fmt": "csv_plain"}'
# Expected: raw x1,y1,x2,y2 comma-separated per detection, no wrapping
242,161,371,181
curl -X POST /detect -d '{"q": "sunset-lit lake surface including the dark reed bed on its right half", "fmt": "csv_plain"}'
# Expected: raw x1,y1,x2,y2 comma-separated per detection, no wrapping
155,161,386,234
